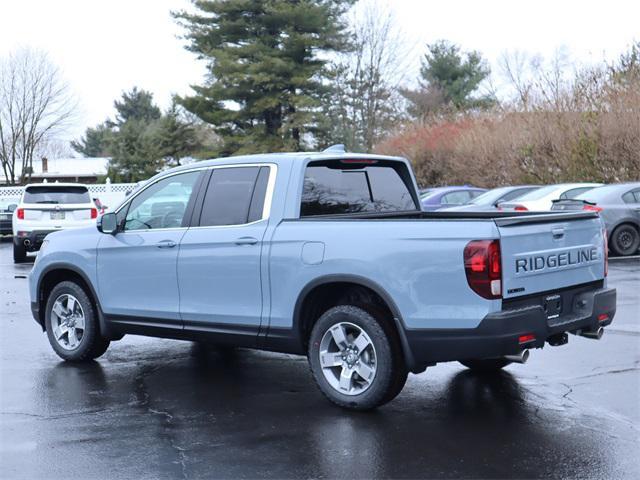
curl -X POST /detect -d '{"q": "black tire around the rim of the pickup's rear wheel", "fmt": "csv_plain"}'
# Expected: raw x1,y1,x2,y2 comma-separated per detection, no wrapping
308,305,407,410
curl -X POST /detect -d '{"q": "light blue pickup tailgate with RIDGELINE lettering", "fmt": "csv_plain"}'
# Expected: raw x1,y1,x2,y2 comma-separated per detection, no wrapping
495,213,605,298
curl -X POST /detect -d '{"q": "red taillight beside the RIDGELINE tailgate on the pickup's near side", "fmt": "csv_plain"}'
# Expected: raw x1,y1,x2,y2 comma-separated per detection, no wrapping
464,240,502,299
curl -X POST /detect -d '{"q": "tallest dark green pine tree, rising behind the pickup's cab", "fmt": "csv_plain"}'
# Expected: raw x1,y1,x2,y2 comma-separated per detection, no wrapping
174,0,354,154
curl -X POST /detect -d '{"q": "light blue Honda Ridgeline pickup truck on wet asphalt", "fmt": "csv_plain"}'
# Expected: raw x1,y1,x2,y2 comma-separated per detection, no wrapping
29,148,616,409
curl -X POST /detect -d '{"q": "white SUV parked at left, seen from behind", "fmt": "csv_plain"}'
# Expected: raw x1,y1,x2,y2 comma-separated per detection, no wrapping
12,183,98,263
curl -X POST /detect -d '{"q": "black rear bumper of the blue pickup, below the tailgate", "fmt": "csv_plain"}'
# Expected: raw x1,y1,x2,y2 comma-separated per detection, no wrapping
406,288,616,366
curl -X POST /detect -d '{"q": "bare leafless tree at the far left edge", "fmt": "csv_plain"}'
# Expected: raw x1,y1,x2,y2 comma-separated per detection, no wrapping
0,49,76,184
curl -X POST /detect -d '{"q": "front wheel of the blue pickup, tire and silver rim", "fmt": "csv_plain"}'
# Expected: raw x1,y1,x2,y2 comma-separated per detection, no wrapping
45,281,109,362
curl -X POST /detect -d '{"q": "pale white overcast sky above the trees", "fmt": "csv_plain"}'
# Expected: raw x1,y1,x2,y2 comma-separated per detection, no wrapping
0,0,640,142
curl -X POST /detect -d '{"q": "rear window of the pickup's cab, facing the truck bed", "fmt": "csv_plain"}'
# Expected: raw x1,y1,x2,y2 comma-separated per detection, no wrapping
300,159,419,217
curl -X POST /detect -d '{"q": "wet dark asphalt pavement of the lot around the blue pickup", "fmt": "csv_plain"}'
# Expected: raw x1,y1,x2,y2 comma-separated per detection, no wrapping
0,241,640,479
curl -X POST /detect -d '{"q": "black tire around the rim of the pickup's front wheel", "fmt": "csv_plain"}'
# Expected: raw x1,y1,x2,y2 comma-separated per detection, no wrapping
45,281,110,362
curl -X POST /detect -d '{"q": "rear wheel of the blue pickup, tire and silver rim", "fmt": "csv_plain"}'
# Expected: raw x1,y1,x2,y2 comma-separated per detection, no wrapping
308,305,407,410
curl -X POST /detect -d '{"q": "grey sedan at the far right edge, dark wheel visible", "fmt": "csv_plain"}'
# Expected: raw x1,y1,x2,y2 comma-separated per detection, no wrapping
552,182,640,255
